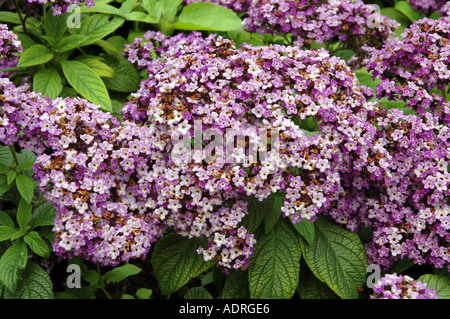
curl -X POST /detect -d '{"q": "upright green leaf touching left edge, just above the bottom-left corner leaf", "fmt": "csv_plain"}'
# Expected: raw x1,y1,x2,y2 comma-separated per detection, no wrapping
0,240,28,291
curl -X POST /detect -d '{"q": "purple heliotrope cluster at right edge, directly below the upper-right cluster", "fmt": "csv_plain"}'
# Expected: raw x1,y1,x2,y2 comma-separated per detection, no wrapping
358,109,450,269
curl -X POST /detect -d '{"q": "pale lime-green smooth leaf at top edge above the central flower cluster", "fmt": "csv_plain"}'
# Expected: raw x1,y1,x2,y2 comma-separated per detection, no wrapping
174,2,242,31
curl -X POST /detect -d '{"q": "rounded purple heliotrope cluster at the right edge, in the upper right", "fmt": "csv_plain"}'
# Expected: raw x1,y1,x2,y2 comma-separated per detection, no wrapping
366,18,450,114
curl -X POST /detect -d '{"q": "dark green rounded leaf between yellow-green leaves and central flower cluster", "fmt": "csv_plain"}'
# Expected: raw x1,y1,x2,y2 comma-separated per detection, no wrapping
103,56,141,93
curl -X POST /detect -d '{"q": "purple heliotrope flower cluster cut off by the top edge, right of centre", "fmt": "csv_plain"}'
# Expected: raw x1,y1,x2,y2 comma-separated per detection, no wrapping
244,0,399,58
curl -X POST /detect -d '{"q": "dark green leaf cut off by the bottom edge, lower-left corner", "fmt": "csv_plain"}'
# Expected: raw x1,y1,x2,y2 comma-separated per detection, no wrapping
6,261,53,299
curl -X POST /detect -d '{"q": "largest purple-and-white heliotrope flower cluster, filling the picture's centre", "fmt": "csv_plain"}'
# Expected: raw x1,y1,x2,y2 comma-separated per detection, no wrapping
122,33,386,268
